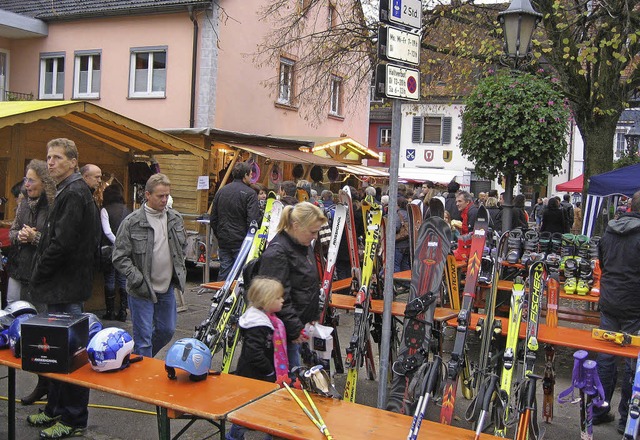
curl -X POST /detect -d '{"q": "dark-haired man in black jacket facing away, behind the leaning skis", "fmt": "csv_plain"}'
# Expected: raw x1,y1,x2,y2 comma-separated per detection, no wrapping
211,162,260,281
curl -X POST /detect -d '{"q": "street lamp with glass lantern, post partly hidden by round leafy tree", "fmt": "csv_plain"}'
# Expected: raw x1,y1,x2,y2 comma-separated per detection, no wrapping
498,0,542,231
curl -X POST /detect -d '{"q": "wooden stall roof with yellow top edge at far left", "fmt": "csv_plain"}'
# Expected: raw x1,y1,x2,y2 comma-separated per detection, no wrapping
0,101,209,159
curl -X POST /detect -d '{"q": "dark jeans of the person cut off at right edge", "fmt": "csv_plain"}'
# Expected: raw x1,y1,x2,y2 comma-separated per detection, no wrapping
593,311,640,424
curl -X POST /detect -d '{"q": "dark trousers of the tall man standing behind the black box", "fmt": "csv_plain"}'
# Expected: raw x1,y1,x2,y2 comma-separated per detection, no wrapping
44,303,89,428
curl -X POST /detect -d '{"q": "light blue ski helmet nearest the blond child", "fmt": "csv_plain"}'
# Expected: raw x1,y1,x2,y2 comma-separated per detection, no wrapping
164,338,211,382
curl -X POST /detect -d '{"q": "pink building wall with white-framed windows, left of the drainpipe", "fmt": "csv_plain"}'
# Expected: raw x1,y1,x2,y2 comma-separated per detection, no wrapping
6,13,193,129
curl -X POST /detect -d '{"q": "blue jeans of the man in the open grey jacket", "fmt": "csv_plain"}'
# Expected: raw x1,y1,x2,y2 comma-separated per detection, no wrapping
129,286,178,357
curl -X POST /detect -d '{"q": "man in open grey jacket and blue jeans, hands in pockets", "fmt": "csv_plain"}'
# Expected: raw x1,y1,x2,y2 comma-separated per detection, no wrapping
112,173,187,357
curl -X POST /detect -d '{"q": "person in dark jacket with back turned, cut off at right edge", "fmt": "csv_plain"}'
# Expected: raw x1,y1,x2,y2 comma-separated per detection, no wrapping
593,191,640,434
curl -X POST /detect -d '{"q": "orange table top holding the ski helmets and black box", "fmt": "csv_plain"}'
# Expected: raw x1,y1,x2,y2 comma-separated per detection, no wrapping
0,350,278,420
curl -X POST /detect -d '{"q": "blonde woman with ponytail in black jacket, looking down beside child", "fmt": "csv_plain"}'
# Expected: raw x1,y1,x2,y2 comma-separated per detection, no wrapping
258,202,327,368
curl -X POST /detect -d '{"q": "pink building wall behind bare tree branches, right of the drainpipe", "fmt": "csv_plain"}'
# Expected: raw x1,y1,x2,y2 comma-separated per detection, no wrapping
216,0,369,145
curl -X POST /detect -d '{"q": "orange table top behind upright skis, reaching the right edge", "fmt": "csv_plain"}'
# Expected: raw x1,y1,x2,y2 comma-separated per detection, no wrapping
447,313,640,358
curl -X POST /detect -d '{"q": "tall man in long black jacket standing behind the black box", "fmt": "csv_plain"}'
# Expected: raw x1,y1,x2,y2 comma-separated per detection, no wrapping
27,138,101,438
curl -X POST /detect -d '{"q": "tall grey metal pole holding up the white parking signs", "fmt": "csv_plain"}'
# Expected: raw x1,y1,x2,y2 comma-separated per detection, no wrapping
378,99,402,409
